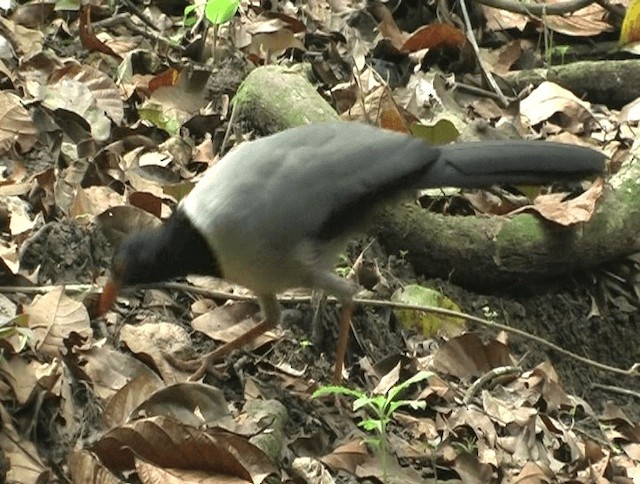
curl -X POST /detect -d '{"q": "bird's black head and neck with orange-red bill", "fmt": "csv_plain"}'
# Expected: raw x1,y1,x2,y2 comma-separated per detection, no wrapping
101,208,222,311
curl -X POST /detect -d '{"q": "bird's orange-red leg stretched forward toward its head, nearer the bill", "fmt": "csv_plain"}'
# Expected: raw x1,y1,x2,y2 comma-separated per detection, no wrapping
189,294,281,381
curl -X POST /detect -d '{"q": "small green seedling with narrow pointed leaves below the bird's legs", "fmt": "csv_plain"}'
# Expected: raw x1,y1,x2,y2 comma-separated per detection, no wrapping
311,371,433,482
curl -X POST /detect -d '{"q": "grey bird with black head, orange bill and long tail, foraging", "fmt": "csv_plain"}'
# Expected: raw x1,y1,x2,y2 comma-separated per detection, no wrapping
100,121,606,382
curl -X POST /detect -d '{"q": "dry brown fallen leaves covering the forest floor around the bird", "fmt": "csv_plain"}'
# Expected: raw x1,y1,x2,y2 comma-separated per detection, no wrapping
0,0,640,483
